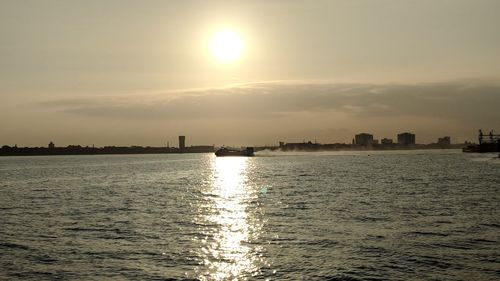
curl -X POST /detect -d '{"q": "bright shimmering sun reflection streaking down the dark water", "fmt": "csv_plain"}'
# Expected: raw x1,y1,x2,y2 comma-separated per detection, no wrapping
194,157,263,280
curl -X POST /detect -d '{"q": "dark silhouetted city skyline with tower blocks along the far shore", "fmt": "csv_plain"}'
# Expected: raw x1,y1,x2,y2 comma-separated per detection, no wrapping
0,131,464,156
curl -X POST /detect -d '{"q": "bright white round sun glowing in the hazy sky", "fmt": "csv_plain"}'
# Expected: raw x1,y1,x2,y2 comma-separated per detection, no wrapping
209,29,243,63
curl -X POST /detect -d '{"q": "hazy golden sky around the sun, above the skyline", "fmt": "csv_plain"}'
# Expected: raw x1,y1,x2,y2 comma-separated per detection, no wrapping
0,0,500,146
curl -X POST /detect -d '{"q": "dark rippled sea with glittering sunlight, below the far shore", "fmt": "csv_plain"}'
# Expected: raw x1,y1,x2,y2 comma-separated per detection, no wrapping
0,150,500,281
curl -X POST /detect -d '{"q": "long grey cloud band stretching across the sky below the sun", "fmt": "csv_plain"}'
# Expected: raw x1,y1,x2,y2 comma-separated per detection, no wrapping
43,80,500,122
